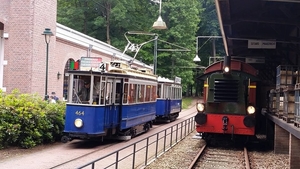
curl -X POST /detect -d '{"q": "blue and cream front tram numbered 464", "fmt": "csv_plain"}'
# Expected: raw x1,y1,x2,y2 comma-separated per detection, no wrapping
61,61,157,142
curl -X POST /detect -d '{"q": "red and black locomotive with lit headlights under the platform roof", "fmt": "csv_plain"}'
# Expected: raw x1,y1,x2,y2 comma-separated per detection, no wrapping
195,56,258,142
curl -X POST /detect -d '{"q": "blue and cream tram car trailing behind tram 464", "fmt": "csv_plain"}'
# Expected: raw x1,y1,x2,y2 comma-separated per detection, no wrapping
156,77,182,122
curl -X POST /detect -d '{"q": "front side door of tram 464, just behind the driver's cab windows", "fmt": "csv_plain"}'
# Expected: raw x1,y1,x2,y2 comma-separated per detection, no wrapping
105,77,123,126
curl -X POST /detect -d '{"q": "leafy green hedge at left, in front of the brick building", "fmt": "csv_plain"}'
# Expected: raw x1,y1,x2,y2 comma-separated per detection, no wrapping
0,90,66,149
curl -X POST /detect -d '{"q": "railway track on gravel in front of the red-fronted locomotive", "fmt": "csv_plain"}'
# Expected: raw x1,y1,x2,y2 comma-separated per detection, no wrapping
189,145,250,169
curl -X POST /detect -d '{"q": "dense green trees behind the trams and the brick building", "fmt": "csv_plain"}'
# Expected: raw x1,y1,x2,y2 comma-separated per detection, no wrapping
57,0,203,93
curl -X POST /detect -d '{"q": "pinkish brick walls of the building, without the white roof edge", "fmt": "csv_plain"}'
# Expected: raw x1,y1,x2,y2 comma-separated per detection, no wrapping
0,0,125,98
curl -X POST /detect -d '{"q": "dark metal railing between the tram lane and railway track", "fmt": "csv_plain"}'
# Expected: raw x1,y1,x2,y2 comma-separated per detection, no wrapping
79,117,195,169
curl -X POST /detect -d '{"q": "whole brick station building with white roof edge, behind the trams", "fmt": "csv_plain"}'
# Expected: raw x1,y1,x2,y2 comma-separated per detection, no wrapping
0,0,146,99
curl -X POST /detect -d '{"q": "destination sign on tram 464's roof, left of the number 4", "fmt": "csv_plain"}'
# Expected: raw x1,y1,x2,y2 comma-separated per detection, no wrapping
80,57,102,71
